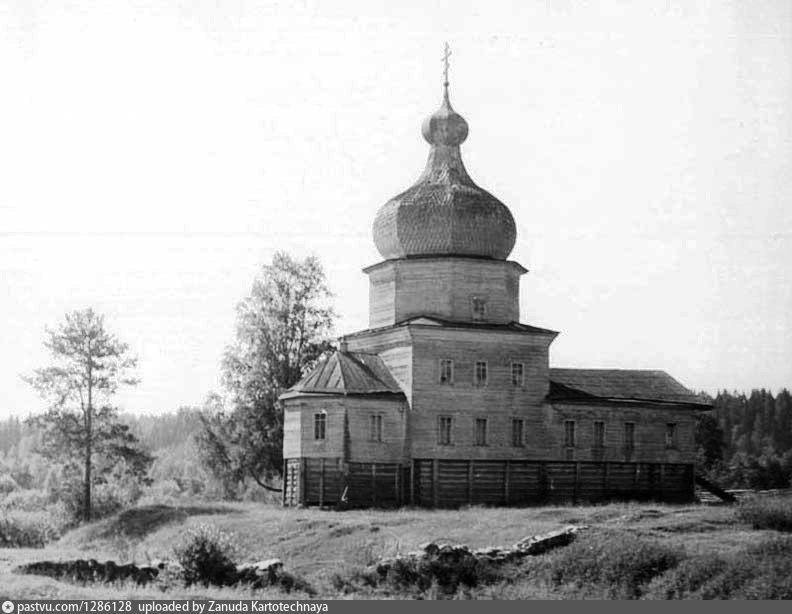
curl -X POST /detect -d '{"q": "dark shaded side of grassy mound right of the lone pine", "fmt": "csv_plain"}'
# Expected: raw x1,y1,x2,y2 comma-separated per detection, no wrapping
91,505,238,539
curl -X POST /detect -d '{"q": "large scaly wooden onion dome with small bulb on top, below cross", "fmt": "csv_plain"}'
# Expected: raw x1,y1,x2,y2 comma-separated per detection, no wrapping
373,83,517,260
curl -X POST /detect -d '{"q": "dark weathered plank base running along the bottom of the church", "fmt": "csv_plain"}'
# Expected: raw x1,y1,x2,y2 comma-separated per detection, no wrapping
283,458,694,507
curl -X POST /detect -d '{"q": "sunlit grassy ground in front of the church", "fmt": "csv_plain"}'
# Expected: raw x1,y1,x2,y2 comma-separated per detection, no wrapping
0,502,792,599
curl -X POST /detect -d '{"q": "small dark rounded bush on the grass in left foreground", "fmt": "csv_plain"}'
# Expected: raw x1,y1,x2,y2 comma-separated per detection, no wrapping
173,524,239,586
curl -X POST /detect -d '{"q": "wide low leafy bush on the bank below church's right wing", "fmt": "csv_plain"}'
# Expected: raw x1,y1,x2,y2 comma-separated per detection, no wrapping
544,531,684,599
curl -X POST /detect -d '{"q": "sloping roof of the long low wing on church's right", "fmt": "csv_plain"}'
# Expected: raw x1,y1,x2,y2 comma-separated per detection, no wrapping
550,369,710,409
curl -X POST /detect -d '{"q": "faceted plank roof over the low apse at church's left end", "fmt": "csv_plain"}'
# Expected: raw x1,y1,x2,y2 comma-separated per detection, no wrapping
286,350,402,395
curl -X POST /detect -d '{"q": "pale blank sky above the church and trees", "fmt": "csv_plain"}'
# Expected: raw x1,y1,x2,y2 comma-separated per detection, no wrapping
0,0,792,416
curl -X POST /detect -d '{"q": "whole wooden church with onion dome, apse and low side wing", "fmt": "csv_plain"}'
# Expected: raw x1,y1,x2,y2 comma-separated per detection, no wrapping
281,73,709,507
